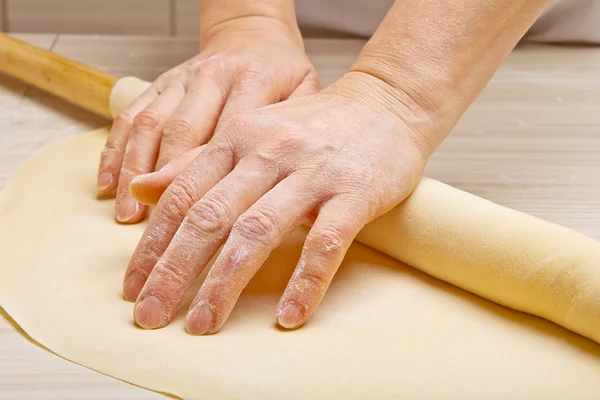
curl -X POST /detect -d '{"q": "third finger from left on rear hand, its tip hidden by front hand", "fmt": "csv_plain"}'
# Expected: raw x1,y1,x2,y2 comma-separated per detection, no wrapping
156,63,233,170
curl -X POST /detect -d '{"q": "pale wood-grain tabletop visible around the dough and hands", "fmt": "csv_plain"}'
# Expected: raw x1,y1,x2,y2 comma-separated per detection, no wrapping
0,35,600,399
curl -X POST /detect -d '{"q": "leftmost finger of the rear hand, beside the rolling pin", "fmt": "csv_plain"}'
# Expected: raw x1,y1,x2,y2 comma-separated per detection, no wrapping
97,85,158,193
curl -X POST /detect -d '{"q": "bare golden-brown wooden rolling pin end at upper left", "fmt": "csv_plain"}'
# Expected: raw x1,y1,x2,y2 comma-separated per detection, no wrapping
0,33,119,119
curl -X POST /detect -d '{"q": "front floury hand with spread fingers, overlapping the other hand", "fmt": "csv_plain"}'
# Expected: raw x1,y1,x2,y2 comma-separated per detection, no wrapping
124,73,428,334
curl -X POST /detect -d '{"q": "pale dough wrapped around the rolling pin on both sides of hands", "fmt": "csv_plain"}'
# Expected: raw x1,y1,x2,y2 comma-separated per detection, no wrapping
111,77,600,343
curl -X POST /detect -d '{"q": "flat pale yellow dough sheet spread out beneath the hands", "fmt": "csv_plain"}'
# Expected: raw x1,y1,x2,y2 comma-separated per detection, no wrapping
0,130,600,400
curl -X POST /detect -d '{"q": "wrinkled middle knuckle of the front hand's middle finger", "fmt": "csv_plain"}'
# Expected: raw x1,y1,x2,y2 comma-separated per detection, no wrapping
186,196,230,234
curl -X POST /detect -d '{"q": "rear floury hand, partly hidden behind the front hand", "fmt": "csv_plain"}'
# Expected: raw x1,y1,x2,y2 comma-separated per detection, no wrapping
98,17,319,223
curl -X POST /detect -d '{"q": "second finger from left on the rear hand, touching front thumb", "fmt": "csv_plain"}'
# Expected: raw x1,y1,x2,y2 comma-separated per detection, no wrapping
115,80,185,223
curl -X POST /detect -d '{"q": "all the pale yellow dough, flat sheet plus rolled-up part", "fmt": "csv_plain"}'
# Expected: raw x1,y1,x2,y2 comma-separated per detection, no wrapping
0,77,600,400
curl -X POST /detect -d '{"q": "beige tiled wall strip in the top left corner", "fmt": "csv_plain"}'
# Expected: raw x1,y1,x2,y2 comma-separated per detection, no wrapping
0,0,199,36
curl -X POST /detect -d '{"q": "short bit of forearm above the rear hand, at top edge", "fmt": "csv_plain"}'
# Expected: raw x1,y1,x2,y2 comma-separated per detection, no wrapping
199,0,302,46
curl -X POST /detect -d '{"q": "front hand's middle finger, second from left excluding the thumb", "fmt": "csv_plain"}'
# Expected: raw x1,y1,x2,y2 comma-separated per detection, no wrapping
135,161,278,329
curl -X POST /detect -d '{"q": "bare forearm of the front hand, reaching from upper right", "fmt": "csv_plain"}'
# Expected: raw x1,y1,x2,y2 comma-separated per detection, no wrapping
332,0,547,153
